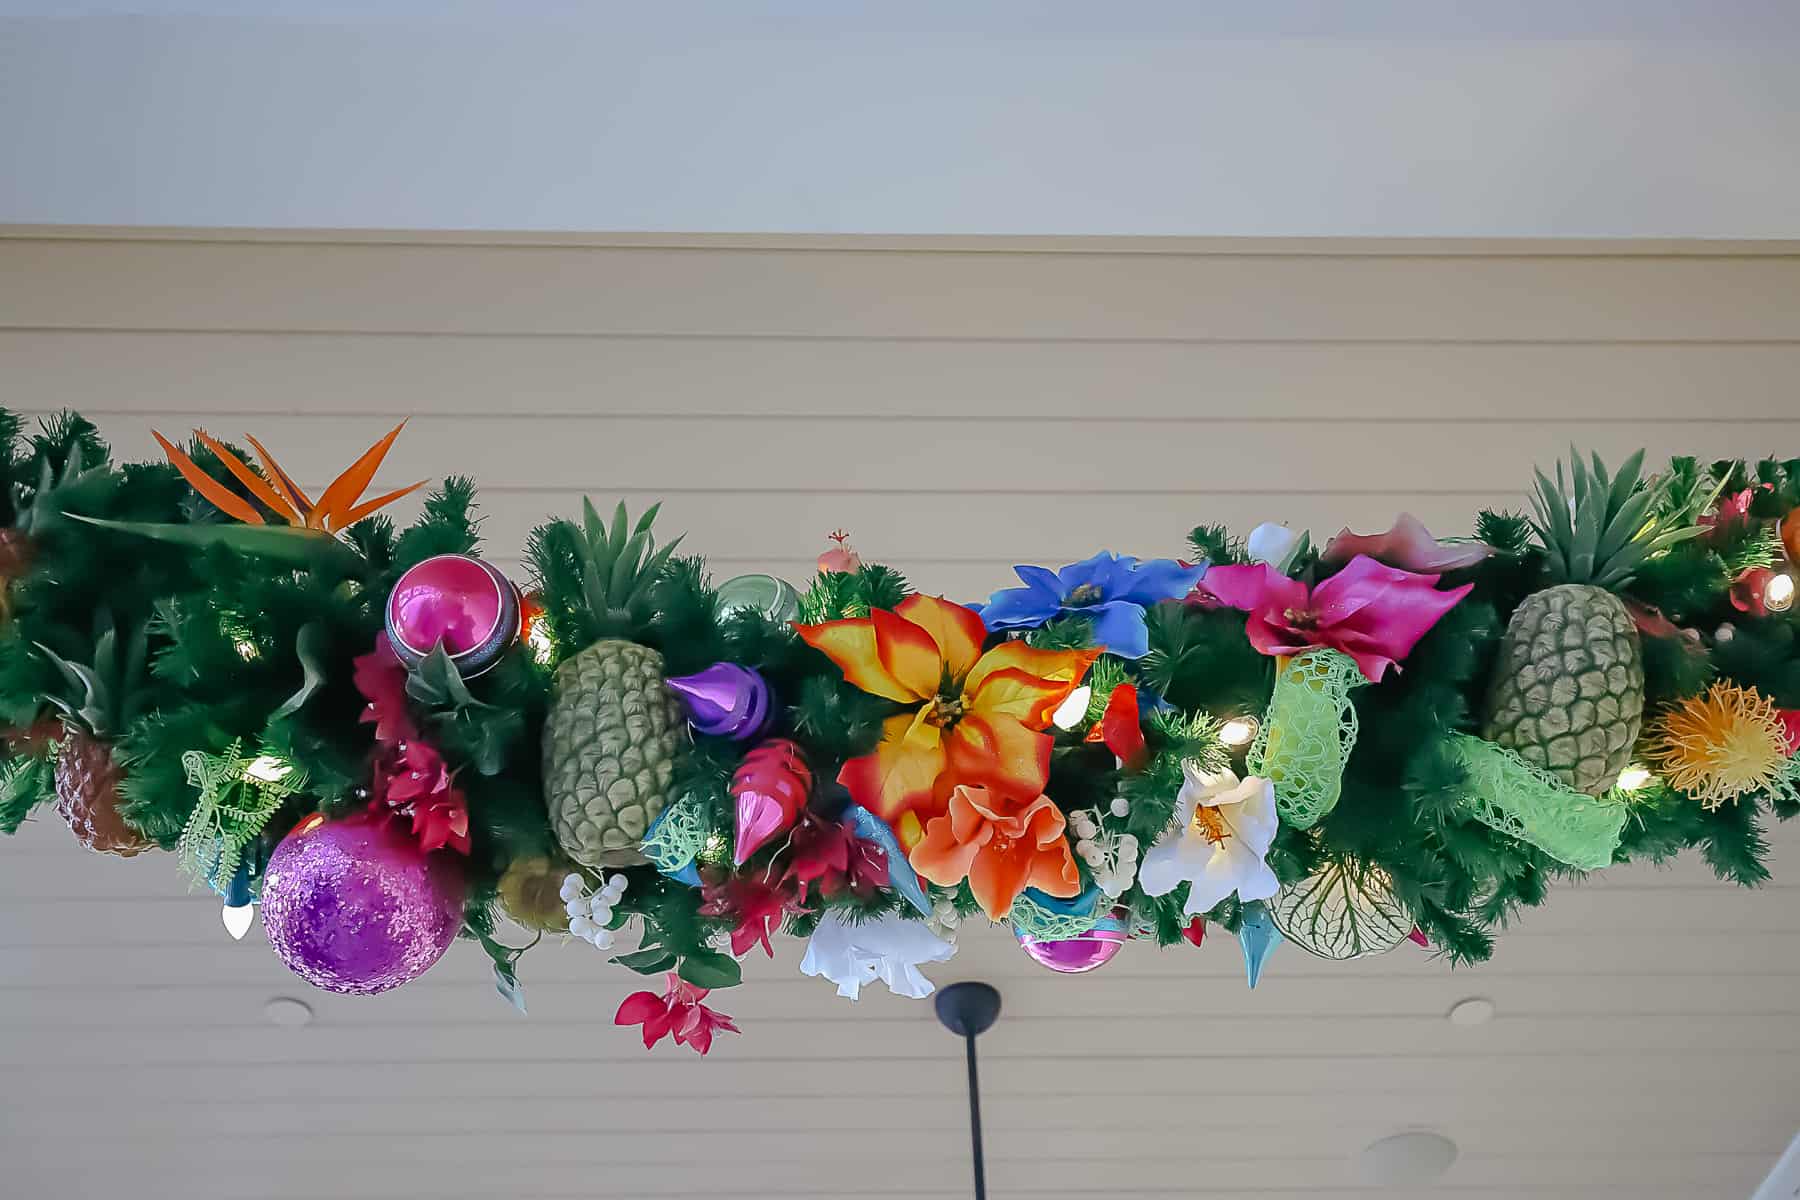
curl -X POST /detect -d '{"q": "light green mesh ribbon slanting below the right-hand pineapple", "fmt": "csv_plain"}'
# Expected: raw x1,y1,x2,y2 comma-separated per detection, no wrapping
1447,734,1629,871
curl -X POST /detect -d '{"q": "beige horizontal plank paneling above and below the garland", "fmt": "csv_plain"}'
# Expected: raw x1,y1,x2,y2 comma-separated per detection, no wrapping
0,230,1800,1200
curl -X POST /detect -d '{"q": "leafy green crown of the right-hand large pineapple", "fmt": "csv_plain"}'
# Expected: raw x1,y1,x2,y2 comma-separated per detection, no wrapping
1532,446,1701,588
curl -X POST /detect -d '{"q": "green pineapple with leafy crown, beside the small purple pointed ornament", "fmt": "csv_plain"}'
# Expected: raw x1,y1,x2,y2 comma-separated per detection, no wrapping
538,502,688,871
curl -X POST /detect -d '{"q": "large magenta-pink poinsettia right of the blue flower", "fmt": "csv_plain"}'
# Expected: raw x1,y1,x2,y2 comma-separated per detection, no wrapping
1199,554,1472,682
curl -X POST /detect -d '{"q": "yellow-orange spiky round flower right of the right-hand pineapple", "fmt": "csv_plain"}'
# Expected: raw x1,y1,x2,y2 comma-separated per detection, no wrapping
1649,682,1787,810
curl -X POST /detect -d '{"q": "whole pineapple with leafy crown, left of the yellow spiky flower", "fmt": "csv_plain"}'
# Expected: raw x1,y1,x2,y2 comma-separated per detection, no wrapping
1483,450,1699,795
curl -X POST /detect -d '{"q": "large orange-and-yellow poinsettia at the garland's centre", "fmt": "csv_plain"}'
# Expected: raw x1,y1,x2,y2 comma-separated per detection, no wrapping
796,596,1100,846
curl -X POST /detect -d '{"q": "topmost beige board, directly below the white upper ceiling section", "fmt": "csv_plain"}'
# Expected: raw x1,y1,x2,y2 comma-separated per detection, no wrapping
0,237,1800,342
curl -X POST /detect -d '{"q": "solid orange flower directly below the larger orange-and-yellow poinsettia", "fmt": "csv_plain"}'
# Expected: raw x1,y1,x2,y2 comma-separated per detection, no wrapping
911,786,1082,921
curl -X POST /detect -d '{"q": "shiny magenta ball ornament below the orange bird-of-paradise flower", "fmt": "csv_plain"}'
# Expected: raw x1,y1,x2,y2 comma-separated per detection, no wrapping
387,554,520,678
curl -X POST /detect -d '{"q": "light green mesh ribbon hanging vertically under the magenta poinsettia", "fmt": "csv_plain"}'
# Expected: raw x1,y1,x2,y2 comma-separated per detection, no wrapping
1247,648,1368,829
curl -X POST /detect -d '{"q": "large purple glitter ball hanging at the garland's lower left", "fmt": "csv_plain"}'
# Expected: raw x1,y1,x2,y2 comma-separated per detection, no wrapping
263,813,464,995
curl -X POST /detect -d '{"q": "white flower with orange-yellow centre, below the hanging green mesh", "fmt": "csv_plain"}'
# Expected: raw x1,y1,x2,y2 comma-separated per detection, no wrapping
1138,763,1282,916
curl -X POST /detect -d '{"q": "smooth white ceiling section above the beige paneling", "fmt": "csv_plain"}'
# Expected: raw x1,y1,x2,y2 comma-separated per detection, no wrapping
0,0,1800,237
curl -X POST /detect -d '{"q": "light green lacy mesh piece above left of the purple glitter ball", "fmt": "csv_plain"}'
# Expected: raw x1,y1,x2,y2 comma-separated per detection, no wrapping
175,741,306,891
